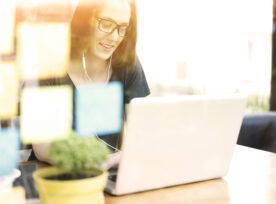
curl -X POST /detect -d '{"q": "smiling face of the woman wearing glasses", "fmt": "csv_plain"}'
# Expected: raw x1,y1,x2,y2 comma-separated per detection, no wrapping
90,0,131,60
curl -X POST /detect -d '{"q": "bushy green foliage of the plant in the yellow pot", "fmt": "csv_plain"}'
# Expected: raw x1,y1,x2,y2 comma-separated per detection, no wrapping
48,132,110,177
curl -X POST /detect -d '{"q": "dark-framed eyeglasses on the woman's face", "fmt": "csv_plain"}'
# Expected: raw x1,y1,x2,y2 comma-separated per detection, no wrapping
96,18,128,37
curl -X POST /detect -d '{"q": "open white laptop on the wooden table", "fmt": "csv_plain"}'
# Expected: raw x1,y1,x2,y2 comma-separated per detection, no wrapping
105,94,247,195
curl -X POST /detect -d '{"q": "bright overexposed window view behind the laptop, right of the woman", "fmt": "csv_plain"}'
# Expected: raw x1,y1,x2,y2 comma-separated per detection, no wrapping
137,0,273,112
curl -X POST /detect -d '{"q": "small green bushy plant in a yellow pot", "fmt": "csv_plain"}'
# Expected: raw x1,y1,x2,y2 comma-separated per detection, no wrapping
33,133,109,204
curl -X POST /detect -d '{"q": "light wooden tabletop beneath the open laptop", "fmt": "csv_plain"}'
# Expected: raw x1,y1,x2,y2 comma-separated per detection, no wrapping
105,145,276,204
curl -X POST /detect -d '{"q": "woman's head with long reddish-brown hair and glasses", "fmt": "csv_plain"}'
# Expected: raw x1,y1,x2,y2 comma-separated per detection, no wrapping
69,0,137,81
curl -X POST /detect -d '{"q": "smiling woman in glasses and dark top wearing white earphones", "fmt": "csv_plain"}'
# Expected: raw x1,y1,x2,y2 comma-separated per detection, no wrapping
33,0,150,167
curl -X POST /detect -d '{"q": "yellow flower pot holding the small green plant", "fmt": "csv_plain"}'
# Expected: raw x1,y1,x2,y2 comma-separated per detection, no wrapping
33,167,107,204
